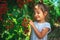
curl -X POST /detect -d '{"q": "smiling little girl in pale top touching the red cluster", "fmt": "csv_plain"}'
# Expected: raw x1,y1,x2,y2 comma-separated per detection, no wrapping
29,3,51,40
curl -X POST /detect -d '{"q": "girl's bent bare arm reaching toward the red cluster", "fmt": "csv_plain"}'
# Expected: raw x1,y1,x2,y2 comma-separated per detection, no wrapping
29,21,49,39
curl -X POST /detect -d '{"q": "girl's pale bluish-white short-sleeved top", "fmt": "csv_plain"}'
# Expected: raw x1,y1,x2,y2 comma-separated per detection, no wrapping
31,22,51,40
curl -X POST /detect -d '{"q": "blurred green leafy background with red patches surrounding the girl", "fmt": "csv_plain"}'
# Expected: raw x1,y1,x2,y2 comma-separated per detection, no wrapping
0,0,60,40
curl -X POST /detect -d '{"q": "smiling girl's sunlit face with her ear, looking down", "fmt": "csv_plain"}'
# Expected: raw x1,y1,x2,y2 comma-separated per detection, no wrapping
34,6,46,21
